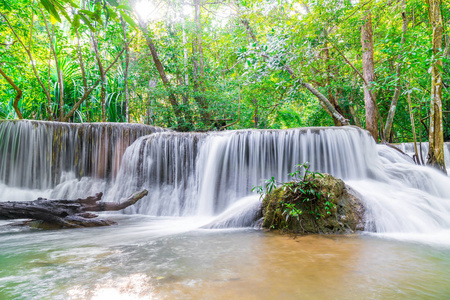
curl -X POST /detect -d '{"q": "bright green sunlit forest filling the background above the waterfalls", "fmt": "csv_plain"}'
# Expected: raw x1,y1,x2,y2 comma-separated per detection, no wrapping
0,0,450,142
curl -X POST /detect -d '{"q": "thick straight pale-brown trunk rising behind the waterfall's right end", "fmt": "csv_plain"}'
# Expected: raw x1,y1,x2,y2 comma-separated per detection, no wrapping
361,10,378,141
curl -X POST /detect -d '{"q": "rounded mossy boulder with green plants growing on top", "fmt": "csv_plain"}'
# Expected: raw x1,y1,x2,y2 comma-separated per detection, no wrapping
262,174,365,234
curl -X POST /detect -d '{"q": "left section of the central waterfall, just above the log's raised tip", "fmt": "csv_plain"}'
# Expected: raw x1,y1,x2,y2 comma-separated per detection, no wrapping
105,132,206,216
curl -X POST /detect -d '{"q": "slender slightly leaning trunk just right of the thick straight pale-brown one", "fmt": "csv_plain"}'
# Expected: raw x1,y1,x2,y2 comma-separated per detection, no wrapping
384,0,408,139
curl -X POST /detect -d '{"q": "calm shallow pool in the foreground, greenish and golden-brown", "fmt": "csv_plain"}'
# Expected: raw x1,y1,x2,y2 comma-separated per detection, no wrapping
0,216,450,299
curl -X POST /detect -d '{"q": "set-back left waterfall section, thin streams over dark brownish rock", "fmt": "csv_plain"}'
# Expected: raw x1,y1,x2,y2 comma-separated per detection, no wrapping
0,121,163,200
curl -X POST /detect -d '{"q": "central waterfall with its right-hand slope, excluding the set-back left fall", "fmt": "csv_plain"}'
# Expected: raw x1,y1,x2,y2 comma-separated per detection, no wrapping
103,127,450,243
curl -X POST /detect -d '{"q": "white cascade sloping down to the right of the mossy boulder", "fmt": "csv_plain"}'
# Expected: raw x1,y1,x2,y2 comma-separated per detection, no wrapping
346,145,450,238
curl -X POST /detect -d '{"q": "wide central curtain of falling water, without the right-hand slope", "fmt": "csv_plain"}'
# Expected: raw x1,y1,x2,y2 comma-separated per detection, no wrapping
107,127,378,216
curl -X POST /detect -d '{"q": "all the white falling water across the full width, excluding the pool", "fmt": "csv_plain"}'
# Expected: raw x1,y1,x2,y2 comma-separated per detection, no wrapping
0,122,450,245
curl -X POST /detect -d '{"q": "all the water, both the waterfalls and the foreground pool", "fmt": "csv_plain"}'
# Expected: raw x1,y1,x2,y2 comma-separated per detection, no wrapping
0,121,450,299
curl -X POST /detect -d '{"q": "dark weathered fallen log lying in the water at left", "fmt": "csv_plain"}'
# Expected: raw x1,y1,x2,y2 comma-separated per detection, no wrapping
0,190,148,229
